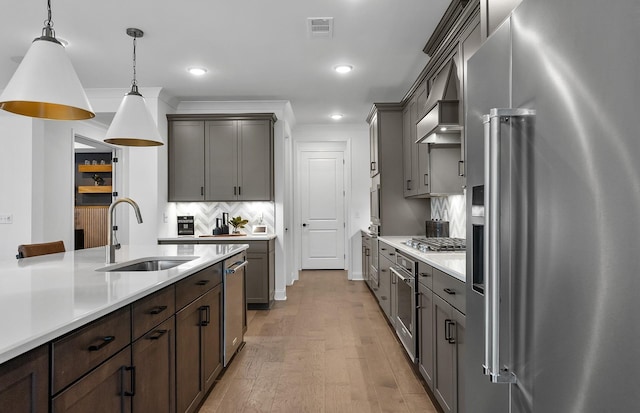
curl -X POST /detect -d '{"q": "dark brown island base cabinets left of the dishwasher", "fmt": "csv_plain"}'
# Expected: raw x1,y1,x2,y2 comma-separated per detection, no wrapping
0,262,230,413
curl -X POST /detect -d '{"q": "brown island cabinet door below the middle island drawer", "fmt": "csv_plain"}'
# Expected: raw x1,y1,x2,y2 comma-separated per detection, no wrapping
132,317,176,413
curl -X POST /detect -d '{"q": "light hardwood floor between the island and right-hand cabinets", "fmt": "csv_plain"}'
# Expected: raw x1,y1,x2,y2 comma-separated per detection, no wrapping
200,271,436,413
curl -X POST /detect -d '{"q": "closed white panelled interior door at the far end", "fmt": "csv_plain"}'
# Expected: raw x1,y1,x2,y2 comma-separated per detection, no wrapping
299,151,345,269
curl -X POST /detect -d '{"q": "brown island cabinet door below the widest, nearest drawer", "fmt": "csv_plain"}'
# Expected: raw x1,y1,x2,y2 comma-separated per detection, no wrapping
52,346,135,413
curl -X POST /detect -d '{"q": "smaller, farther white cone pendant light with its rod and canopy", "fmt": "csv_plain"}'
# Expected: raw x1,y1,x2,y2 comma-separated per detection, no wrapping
104,28,163,146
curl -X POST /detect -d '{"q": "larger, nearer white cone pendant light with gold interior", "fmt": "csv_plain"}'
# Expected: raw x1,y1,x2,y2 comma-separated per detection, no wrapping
0,0,95,120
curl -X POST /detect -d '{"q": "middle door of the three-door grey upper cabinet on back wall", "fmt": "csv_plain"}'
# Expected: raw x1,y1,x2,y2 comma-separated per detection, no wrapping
205,120,238,201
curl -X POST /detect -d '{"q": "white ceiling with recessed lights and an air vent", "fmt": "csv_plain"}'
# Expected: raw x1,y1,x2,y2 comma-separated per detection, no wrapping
0,0,449,124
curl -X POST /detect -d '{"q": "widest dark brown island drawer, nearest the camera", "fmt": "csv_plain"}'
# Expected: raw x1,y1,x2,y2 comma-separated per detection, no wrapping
51,306,131,394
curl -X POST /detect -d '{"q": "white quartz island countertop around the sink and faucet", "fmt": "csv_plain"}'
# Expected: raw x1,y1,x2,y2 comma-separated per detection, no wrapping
0,244,248,363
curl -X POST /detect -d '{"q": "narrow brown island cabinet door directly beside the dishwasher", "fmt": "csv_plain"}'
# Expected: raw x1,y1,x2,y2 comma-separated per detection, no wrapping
201,285,223,393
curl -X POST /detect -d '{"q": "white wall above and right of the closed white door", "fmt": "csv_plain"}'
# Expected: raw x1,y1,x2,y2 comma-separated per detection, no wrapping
293,121,371,280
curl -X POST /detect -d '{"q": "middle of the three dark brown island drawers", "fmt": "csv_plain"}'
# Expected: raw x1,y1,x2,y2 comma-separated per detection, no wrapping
131,285,176,340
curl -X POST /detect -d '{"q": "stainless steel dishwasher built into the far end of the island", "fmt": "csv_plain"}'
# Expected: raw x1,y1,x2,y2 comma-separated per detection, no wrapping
223,252,248,367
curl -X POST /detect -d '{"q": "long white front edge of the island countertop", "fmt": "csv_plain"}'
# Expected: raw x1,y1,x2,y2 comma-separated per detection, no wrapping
0,244,249,364
